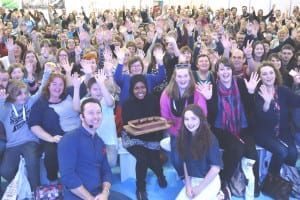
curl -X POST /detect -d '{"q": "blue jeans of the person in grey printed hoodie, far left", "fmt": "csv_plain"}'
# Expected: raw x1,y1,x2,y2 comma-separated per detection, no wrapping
0,142,40,191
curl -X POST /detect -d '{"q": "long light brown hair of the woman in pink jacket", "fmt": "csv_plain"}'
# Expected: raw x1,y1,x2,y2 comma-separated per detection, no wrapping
165,67,195,100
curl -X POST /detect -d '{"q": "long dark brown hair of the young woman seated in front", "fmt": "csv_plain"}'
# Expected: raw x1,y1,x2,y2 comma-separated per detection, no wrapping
177,104,212,159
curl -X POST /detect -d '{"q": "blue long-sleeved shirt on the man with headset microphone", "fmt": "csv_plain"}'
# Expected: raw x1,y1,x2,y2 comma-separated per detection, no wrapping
58,126,112,200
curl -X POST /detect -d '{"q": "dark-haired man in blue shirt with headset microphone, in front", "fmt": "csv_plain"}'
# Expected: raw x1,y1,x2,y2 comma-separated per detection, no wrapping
58,98,112,200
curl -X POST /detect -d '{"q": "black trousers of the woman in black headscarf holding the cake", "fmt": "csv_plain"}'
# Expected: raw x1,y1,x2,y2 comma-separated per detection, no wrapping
127,145,163,191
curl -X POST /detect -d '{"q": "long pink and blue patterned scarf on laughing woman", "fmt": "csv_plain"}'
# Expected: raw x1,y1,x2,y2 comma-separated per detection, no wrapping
217,79,245,137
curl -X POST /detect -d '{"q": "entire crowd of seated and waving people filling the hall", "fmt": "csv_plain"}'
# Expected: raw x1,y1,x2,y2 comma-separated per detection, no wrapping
0,3,300,200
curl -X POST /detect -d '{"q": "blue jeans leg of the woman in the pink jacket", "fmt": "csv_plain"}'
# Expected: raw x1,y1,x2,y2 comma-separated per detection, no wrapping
170,135,184,178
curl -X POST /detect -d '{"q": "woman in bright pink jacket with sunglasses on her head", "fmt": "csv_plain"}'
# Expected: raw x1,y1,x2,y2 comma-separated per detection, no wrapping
160,64,207,178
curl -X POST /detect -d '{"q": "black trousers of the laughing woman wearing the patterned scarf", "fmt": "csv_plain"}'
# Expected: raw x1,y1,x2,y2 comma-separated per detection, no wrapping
214,129,259,184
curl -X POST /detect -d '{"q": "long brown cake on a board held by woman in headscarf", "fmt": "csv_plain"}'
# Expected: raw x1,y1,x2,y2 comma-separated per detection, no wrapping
124,116,171,135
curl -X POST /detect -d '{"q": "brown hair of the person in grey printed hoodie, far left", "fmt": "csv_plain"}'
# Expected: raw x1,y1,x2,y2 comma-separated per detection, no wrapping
6,80,28,103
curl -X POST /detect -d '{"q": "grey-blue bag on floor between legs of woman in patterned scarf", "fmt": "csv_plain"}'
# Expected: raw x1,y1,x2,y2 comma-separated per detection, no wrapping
228,163,247,197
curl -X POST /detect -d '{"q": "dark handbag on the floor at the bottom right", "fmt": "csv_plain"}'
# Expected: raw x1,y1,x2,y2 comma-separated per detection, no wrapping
262,173,293,200
